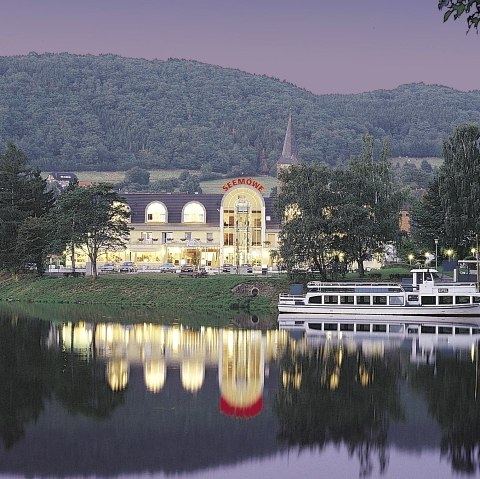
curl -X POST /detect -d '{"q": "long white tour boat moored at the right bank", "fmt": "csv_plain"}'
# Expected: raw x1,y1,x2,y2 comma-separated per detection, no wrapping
278,269,480,317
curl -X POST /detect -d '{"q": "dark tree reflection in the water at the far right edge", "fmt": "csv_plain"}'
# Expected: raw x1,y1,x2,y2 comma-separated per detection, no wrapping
410,351,480,474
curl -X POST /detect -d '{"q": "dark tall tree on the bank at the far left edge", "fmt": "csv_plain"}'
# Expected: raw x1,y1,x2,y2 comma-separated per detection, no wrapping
0,144,54,272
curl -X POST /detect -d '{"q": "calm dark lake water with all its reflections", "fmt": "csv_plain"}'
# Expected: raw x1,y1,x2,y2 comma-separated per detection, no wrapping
0,306,480,479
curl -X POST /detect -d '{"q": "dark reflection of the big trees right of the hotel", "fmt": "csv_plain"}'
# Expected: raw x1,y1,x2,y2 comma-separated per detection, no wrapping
275,344,402,476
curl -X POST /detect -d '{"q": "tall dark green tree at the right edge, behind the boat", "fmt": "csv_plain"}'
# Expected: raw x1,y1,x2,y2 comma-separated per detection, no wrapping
438,124,480,254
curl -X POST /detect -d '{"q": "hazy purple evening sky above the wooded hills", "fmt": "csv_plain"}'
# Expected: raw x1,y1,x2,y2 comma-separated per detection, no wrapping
0,0,480,94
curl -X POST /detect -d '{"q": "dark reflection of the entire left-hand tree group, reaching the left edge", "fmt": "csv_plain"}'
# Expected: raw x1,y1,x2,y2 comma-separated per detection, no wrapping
0,313,123,448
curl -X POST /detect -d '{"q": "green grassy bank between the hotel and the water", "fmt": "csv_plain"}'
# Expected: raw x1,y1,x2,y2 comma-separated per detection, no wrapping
0,273,289,317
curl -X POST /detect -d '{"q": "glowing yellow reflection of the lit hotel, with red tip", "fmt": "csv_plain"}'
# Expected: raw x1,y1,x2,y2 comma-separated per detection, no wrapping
51,323,288,417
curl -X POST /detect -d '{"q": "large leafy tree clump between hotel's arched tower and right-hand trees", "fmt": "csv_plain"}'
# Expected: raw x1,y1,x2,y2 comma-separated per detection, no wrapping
277,135,404,278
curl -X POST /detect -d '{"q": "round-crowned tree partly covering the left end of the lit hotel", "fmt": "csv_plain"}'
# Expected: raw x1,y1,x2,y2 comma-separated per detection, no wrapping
55,183,130,278
